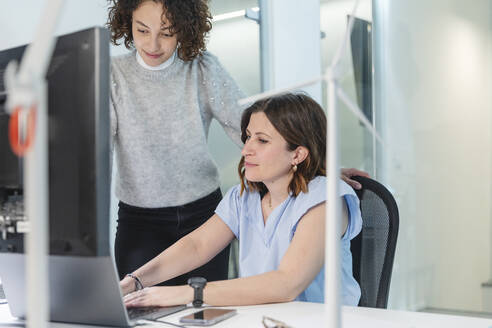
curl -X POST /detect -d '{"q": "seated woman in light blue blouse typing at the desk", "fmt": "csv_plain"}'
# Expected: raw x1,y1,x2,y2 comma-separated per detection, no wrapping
121,94,362,306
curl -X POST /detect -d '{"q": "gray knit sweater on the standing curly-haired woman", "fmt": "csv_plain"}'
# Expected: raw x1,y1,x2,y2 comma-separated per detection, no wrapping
111,52,244,208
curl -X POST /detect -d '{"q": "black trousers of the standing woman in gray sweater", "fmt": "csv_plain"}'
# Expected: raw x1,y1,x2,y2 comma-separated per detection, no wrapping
114,189,230,286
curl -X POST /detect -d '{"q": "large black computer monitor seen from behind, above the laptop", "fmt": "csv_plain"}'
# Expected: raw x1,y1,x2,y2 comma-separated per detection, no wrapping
0,27,110,256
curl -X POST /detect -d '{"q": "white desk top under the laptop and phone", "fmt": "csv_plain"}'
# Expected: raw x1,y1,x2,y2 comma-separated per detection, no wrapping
0,302,492,328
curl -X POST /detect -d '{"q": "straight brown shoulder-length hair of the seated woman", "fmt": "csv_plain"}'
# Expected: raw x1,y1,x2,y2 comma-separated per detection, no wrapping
238,93,326,196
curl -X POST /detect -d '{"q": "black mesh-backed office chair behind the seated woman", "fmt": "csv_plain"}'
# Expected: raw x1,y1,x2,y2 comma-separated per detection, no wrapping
350,176,399,308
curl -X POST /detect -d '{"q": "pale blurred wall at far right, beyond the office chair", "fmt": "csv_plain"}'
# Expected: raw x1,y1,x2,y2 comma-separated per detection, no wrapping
374,0,492,311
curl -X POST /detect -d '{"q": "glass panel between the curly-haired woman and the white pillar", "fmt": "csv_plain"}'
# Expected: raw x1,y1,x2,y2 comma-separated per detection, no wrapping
207,0,261,193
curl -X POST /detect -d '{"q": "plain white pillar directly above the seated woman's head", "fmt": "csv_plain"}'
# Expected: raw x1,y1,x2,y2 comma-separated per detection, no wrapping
260,0,322,103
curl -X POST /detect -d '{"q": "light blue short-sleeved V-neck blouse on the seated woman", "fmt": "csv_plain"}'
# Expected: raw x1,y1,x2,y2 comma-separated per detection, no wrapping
215,176,362,306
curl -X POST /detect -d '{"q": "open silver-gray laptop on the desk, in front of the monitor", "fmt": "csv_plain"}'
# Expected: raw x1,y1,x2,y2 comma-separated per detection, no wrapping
0,253,186,327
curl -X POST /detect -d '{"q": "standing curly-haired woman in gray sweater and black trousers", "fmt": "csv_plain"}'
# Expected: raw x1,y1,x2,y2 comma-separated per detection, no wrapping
108,0,244,285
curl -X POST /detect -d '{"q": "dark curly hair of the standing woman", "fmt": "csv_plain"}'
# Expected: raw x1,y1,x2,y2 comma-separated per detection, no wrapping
106,0,212,61
